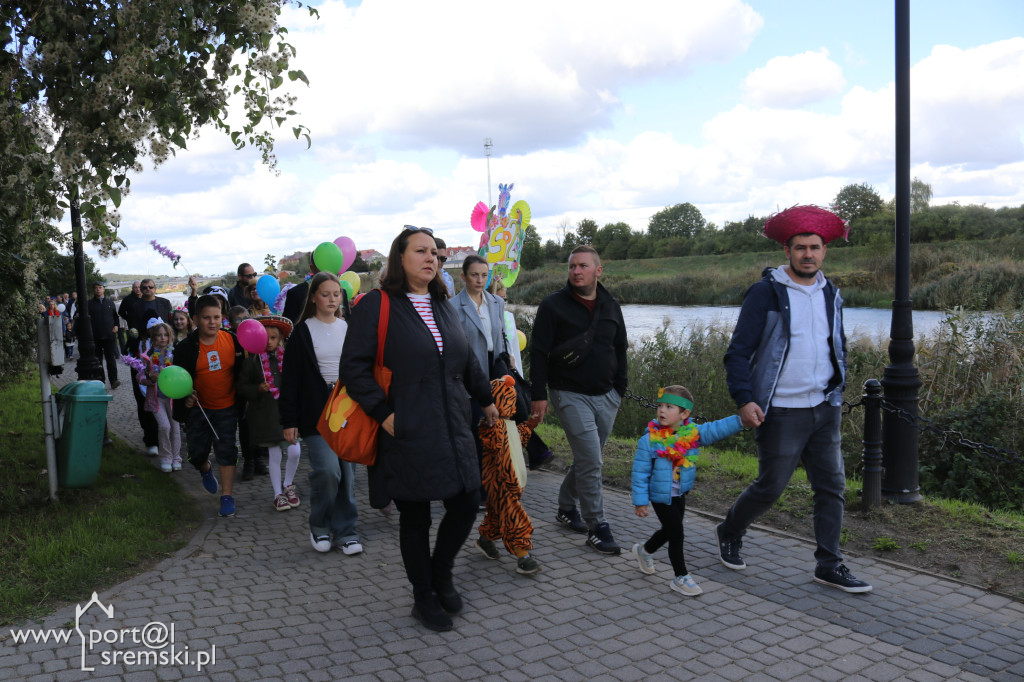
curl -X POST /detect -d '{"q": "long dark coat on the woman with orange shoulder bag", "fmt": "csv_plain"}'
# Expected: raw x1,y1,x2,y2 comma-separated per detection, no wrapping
339,290,495,501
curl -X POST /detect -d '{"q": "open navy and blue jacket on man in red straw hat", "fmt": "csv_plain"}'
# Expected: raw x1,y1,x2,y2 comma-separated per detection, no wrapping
725,267,846,416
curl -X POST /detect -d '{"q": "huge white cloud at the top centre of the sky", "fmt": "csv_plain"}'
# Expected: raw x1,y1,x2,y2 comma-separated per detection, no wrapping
278,0,762,153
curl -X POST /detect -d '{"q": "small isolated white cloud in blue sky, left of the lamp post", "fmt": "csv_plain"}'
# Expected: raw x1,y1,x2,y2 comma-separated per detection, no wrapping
743,47,846,109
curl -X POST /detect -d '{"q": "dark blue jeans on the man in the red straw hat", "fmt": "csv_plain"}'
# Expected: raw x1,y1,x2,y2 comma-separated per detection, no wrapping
721,401,846,568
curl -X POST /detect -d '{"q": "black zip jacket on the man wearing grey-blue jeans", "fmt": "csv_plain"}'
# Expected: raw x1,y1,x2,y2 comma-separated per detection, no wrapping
529,283,629,400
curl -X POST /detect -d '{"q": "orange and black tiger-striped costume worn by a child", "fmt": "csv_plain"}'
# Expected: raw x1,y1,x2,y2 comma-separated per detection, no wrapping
480,376,537,556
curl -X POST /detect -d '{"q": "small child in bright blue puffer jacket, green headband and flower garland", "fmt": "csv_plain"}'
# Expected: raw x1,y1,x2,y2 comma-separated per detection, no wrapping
633,386,741,597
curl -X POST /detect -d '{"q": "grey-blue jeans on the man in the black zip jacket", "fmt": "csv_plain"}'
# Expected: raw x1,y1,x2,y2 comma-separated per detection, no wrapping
549,389,622,528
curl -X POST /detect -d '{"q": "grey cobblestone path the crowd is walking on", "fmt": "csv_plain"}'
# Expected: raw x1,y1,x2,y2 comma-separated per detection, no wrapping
0,360,1024,682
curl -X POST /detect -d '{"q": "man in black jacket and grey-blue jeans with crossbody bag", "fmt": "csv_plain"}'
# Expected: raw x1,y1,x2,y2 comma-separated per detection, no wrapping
529,246,628,554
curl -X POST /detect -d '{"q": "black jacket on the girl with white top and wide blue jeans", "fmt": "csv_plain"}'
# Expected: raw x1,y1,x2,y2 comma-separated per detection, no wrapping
278,323,333,437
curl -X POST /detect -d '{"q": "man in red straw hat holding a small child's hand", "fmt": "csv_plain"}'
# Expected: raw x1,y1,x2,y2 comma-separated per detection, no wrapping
716,201,871,593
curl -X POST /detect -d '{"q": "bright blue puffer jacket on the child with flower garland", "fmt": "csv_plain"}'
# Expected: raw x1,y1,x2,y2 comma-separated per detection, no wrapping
633,415,742,507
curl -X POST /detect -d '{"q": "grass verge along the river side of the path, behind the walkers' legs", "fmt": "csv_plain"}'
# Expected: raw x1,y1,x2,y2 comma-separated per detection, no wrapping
538,417,1024,601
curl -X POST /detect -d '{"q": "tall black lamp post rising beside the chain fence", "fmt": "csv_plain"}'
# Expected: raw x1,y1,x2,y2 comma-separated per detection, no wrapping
882,0,921,504
